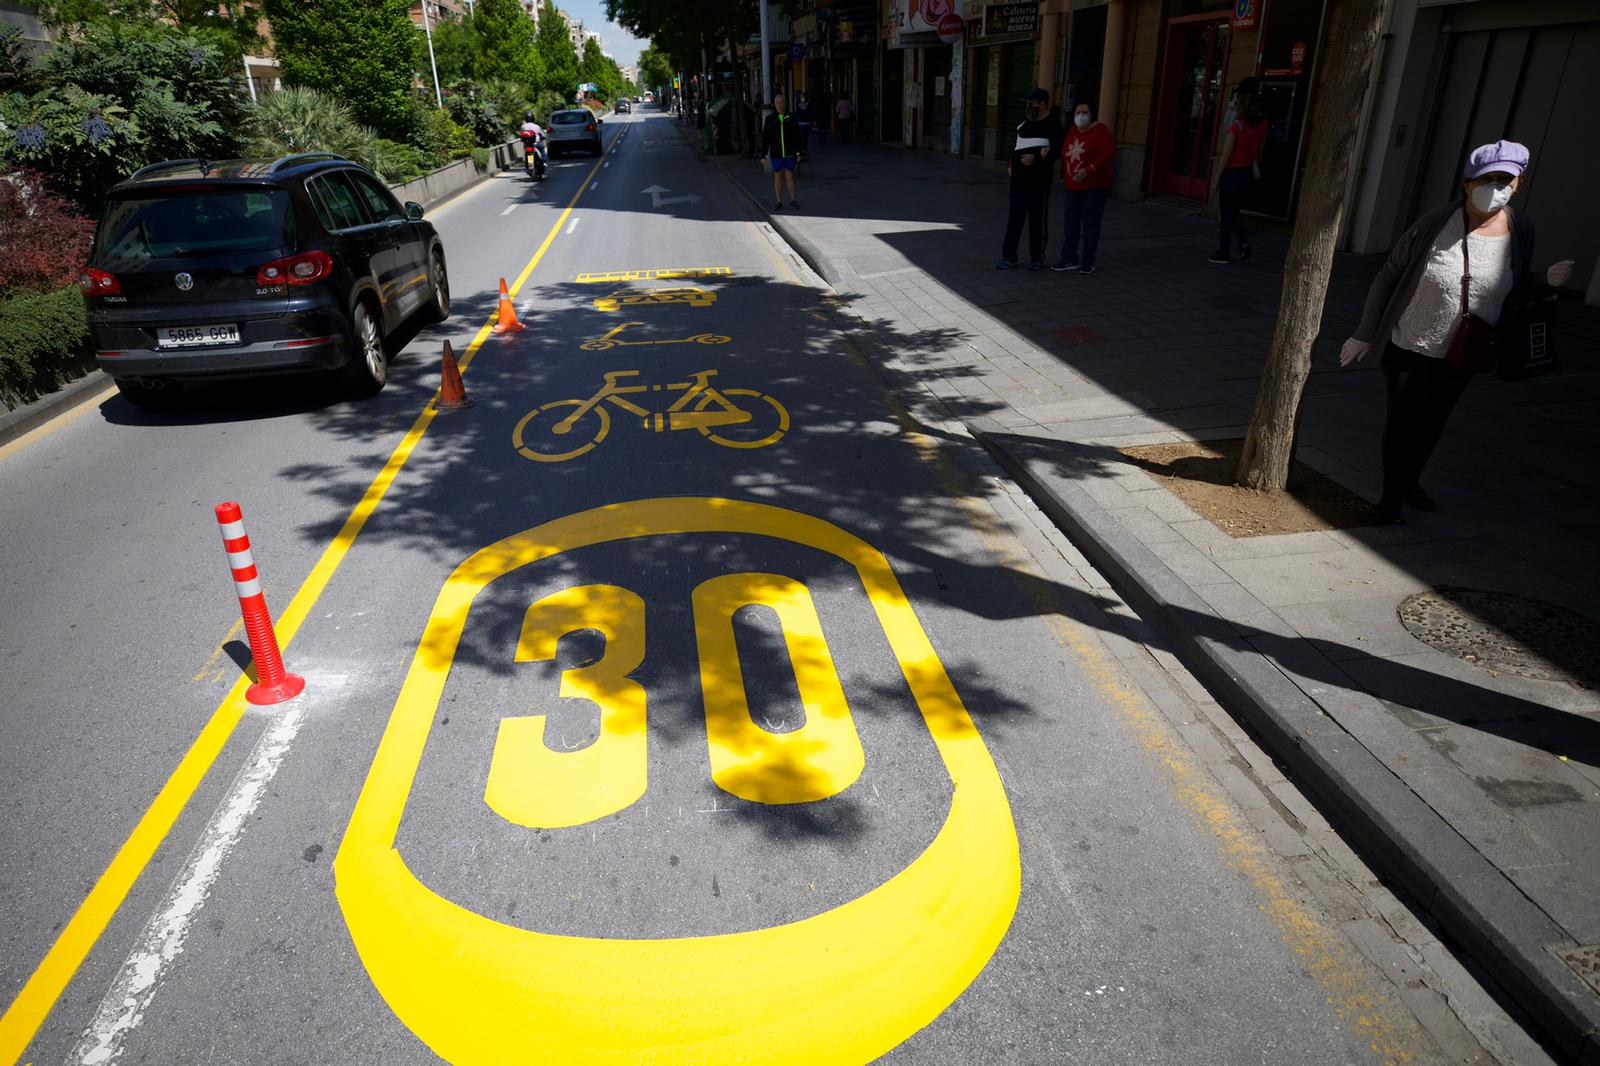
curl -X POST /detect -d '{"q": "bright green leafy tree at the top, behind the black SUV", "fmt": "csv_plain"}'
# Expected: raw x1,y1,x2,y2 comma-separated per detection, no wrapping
266,0,424,139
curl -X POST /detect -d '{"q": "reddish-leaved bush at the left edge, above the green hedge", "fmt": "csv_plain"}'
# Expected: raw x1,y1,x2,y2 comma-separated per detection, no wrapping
0,171,94,299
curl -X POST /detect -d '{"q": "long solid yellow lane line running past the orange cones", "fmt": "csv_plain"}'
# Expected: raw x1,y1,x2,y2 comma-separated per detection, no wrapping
0,135,610,1063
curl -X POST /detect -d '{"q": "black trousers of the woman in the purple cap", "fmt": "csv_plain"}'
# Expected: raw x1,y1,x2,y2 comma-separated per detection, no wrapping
1379,343,1472,507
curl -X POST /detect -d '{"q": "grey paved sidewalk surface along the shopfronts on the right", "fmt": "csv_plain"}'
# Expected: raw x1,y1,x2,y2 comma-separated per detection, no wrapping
720,136,1600,966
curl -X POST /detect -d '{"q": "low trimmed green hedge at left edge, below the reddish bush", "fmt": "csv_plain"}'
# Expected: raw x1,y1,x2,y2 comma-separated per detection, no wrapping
0,285,94,408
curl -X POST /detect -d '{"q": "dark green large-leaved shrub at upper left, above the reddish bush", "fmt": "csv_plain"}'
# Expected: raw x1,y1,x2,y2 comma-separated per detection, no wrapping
0,21,246,211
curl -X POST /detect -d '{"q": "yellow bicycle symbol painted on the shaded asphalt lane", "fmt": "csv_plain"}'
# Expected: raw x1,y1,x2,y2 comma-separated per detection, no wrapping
510,370,789,463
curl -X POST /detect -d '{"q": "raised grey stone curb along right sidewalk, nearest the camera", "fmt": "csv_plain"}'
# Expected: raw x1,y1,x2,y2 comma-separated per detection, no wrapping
970,427,1600,1066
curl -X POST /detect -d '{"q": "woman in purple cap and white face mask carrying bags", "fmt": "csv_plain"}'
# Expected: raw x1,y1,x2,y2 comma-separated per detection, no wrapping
1339,141,1573,522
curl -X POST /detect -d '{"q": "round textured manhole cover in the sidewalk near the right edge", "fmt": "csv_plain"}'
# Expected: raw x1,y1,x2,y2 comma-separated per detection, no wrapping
1398,586,1600,688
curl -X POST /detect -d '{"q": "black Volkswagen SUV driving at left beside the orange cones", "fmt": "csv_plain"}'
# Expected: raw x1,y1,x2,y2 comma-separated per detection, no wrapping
78,152,450,407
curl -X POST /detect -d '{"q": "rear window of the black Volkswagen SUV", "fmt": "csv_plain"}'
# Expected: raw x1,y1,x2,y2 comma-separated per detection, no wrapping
98,186,294,259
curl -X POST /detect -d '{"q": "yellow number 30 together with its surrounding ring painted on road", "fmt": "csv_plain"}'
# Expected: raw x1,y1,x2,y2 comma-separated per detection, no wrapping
334,498,1021,1066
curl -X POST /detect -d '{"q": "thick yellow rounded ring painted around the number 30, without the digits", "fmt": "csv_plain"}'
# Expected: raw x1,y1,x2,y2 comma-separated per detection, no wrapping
334,498,1021,1066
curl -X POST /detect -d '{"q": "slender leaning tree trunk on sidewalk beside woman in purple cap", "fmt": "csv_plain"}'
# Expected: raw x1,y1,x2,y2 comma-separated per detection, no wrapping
1235,0,1384,493
